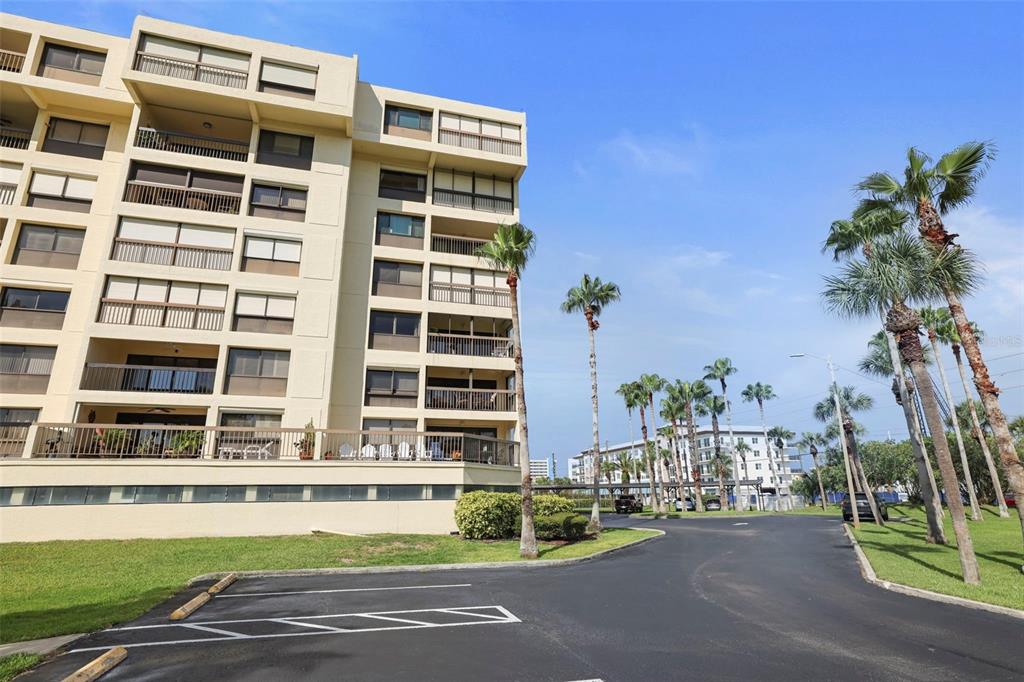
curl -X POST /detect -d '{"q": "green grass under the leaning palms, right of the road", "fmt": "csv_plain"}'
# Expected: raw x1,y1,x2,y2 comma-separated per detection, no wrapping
854,505,1024,609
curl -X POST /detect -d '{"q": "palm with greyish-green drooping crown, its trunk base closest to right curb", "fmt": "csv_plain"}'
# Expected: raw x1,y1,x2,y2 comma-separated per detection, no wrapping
822,232,980,585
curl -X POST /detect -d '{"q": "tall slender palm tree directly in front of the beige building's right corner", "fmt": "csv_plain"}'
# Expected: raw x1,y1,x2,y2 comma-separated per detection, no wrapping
476,222,544,559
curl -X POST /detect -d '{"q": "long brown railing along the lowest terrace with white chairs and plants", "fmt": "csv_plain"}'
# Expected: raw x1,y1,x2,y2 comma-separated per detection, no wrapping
30,424,519,466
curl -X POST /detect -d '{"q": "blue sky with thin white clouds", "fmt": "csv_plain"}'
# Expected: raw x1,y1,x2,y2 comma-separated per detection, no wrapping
9,0,1024,471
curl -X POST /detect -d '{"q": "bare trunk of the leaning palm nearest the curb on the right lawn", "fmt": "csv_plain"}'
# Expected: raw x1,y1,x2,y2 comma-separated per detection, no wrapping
886,302,981,585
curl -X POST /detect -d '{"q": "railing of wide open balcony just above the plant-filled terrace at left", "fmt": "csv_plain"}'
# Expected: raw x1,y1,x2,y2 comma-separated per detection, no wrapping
82,363,217,395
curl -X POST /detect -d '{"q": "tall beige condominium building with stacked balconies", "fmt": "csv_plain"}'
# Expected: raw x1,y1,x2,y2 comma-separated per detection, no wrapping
0,14,526,540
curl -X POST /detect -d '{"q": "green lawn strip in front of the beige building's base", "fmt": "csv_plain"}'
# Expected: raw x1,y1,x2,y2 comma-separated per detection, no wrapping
0,528,656,642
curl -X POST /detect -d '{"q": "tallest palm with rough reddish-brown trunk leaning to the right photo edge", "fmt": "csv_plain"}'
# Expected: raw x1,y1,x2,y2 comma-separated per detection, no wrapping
857,141,1024,534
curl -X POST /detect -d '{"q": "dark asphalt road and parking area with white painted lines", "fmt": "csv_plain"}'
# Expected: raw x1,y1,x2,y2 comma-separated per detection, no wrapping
26,516,1024,682
